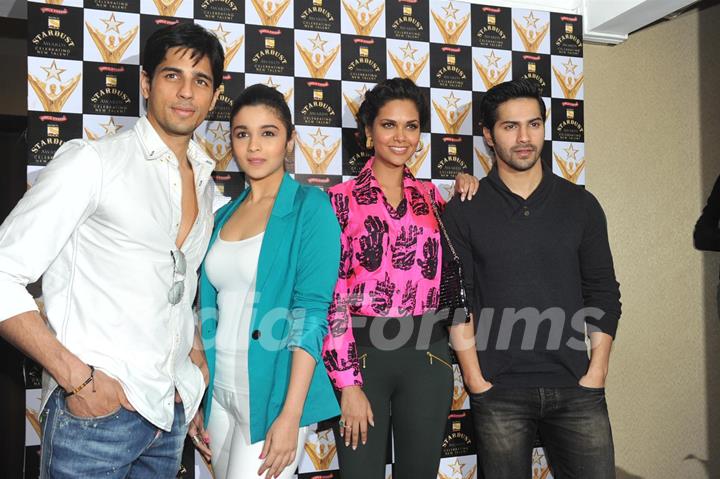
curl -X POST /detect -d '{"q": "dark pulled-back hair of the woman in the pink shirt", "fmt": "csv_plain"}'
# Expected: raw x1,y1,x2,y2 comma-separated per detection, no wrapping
355,77,430,150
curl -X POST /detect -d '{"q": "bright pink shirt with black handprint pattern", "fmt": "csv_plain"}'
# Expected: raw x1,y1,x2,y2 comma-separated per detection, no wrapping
323,158,444,389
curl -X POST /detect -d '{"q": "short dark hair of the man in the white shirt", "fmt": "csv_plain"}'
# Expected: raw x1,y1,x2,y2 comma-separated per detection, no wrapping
143,23,225,90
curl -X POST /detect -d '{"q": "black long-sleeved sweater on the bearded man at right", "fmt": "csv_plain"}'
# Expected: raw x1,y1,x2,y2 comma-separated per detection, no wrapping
443,168,620,387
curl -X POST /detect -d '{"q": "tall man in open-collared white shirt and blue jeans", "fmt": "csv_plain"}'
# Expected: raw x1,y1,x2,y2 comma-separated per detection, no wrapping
0,24,224,478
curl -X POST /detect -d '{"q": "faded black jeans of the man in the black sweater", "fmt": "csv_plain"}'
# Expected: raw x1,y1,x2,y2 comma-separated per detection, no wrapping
470,386,615,479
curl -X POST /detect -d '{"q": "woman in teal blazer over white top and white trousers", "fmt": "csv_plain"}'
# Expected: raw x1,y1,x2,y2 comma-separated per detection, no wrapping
191,85,340,479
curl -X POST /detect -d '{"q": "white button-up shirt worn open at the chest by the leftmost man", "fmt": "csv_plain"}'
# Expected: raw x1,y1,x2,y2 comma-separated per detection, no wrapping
0,117,215,430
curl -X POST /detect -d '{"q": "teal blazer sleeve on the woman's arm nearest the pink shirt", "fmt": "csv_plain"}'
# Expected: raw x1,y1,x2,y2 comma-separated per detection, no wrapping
288,189,340,362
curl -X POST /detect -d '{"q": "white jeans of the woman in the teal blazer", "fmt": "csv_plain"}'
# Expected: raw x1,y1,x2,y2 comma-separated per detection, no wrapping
208,386,309,479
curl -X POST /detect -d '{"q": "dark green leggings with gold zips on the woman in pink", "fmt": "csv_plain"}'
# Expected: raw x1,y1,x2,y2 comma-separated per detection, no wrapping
333,337,453,479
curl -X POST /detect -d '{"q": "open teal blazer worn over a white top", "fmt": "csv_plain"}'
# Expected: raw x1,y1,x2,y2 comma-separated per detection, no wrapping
199,173,340,443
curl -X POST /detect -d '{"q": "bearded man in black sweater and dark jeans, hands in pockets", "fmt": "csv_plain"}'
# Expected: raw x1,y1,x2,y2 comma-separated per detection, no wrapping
443,80,620,479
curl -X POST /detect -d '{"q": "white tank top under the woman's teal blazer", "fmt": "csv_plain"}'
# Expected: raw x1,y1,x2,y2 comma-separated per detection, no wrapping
205,232,265,392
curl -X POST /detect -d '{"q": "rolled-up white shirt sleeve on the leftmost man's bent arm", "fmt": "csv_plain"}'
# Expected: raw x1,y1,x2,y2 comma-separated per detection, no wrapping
0,140,102,321
